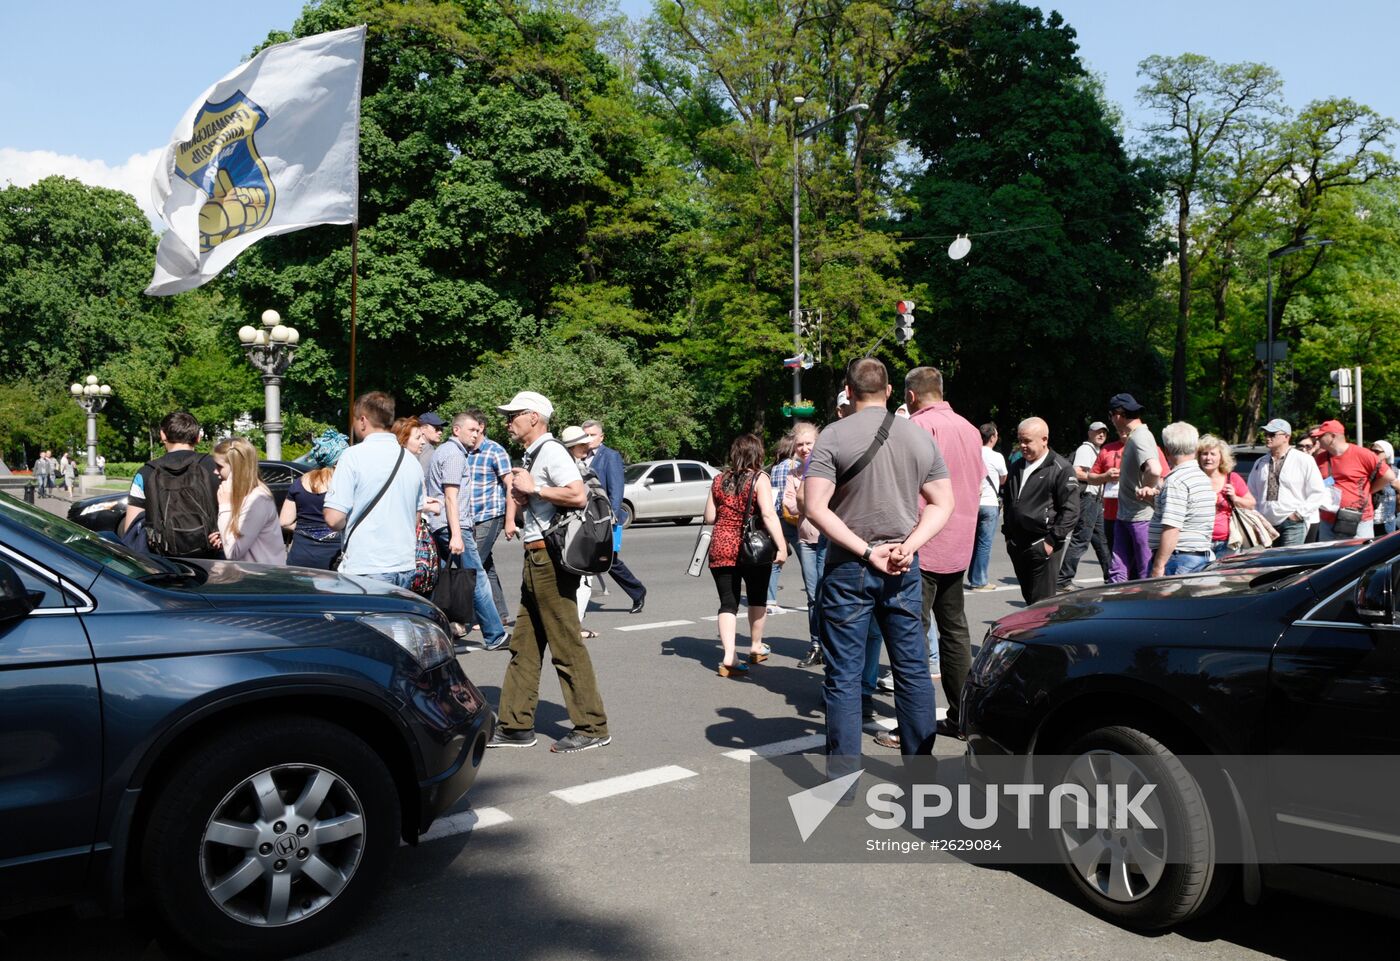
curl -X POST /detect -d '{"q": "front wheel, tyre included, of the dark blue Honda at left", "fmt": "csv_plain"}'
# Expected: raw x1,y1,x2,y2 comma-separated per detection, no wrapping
141,717,400,958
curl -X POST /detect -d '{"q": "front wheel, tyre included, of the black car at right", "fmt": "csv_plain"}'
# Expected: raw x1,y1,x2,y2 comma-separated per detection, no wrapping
1050,727,1224,929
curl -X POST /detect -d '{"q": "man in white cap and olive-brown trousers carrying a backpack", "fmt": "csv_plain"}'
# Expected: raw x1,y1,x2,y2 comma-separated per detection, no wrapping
487,391,612,754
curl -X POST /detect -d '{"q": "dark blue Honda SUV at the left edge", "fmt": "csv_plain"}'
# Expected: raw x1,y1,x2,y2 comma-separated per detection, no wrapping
0,495,493,957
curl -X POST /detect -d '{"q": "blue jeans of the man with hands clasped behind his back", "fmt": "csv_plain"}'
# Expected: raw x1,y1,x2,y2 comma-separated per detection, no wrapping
820,549,935,775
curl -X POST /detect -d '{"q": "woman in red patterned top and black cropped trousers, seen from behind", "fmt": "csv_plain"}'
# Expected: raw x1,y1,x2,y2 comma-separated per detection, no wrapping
704,434,787,678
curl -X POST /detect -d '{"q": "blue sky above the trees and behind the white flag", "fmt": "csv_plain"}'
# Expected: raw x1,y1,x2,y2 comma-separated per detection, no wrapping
0,0,1400,217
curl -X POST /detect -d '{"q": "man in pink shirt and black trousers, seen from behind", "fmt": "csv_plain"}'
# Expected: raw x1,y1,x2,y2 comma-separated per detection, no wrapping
904,367,986,738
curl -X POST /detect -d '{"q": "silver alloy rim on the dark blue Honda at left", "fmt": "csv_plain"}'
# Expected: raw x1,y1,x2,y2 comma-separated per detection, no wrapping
199,763,365,927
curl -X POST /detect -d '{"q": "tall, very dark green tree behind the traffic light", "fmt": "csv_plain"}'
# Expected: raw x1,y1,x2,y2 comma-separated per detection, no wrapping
900,3,1161,440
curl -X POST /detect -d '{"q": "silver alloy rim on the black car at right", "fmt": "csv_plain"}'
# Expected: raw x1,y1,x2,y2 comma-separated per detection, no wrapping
1060,751,1166,904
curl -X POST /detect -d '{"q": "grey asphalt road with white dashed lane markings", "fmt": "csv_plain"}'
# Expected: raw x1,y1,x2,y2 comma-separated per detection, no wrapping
0,524,1393,961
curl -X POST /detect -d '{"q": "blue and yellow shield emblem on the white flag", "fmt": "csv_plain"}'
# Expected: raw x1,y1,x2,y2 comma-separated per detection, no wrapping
175,90,277,254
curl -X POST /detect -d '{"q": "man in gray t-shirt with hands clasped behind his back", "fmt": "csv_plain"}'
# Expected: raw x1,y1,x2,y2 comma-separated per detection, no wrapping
804,357,953,776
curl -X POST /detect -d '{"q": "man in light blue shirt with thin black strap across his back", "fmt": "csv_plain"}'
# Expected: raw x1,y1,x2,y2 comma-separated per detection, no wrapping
325,391,426,588
